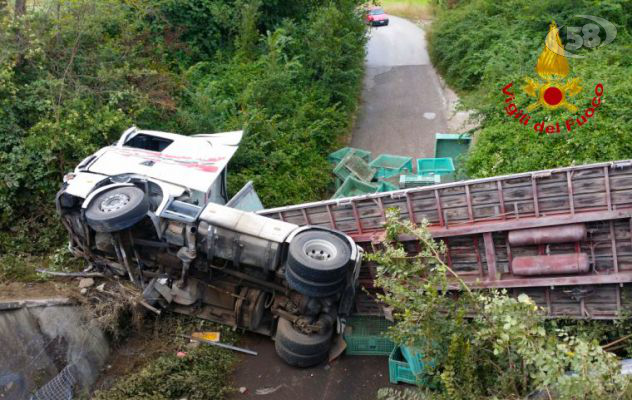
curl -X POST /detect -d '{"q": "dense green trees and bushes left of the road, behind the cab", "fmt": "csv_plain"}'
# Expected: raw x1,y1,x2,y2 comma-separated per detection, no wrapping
0,0,365,281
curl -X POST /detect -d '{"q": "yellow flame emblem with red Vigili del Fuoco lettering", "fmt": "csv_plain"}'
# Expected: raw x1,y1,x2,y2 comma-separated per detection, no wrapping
502,22,603,134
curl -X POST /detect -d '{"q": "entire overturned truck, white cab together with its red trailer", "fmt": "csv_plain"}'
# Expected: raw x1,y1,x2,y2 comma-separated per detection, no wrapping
56,128,632,366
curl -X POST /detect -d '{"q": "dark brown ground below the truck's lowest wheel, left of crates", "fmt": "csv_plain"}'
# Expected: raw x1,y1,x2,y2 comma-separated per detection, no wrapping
229,334,398,400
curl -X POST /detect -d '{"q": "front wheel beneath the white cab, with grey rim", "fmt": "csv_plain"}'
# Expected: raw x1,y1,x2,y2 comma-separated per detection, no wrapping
85,186,149,232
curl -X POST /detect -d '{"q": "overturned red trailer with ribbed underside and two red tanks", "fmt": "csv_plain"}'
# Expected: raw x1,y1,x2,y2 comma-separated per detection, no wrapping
259,160,632,319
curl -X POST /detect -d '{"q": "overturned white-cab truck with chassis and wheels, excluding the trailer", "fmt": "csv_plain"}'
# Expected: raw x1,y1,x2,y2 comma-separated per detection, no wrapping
56,128,362,367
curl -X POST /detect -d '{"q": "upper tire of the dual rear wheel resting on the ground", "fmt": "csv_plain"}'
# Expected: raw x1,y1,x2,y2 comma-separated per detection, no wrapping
274,318,333,355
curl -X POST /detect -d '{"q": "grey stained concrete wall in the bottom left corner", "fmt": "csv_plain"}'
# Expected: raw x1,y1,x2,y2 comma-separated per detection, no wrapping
0,301,109,400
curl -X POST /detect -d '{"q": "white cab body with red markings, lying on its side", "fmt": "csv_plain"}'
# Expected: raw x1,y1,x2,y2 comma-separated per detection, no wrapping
64,127,243,230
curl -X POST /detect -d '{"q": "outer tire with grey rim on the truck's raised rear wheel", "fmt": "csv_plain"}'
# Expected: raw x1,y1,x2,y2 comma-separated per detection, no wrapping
287,229,351,283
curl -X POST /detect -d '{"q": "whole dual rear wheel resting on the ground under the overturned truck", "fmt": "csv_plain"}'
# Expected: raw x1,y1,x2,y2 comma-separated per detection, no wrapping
274,318,333,368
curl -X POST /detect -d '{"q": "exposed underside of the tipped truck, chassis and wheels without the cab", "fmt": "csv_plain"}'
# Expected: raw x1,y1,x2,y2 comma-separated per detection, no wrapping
57,188,362,366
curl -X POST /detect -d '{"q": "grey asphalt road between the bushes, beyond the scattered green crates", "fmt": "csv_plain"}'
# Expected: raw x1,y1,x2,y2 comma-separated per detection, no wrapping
351,16,449,162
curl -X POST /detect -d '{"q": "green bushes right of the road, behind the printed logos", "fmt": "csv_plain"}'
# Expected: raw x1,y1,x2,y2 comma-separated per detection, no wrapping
430,0,632,177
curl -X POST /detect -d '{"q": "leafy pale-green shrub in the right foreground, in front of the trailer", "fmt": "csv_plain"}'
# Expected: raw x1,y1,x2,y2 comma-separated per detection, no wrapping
368,210,632,400
